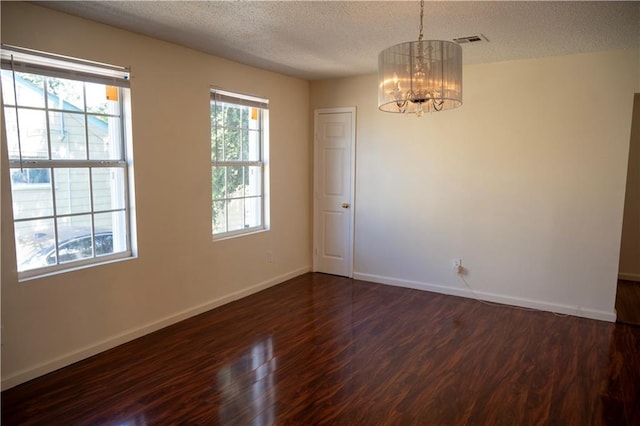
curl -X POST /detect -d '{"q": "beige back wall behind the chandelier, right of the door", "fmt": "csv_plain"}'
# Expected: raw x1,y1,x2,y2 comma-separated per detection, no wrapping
311,50,639,321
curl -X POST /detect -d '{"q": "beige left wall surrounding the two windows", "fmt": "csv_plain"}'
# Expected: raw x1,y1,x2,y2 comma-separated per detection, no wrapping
1,2,311,388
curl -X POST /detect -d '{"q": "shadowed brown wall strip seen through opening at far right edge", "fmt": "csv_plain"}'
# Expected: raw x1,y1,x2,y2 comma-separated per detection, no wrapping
619,93,640,281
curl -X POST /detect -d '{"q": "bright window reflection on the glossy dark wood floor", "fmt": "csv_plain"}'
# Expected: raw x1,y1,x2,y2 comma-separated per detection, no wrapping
217,336,277,425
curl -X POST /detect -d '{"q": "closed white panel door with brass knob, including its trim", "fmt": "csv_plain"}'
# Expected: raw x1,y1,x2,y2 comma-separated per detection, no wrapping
313,108,356,277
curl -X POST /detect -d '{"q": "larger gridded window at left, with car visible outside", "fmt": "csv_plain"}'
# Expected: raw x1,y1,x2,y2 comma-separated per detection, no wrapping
0,45,132,278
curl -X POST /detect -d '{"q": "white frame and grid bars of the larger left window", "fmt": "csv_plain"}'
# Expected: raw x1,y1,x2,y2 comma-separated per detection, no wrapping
0,44,136,281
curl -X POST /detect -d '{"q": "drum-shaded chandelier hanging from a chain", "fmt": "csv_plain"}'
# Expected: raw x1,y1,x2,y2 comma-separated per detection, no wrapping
378,0,462,117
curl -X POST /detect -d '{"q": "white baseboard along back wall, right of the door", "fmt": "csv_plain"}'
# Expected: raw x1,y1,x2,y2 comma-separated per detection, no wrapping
353,272,616,322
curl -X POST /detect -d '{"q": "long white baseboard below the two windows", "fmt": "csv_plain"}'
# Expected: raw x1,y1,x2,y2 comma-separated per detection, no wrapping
1,266,311,391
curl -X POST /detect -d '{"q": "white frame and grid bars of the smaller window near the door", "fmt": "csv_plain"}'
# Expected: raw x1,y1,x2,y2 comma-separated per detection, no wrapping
209,87,270,241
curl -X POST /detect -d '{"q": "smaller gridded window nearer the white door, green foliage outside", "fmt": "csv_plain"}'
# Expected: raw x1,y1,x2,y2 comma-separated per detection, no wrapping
211,90,269,238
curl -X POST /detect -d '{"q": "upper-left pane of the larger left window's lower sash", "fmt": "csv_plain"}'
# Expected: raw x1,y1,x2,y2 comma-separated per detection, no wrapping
10,169,53,220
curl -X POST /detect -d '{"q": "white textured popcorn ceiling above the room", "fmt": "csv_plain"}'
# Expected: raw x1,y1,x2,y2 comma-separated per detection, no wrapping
35,1,640,80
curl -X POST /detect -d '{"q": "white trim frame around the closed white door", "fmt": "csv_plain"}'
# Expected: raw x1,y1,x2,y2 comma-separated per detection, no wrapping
312,107,356,278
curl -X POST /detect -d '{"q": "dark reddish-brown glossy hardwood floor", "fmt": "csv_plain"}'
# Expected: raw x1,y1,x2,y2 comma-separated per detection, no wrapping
2,274,640,426
